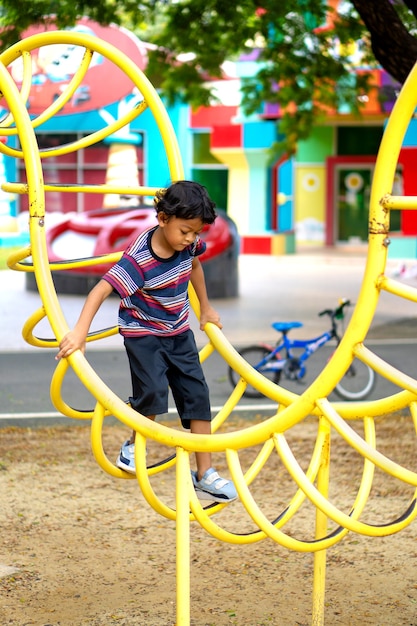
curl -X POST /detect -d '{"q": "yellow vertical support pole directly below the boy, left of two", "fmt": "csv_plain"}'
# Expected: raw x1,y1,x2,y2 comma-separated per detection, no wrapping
176,447,191,626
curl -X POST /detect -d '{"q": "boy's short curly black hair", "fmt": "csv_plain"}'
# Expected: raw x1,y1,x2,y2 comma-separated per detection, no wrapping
155,180,217,224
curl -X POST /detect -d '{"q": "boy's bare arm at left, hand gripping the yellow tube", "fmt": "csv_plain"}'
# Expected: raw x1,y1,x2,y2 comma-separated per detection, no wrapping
55,280,113,360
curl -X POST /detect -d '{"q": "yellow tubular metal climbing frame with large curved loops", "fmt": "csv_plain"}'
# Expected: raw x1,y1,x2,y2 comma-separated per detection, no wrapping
0,31,417,626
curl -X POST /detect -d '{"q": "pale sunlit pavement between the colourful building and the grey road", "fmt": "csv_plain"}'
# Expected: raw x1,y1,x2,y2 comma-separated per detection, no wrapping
0,246,417,352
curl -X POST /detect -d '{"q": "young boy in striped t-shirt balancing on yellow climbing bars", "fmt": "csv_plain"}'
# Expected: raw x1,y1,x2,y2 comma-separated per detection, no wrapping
56,181,237,502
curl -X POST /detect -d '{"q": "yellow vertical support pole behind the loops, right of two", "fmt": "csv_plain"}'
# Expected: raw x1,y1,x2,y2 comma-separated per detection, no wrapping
311,417,330,626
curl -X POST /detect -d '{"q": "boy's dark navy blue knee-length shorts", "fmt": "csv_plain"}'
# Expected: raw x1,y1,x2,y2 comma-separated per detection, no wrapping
124,330,211,428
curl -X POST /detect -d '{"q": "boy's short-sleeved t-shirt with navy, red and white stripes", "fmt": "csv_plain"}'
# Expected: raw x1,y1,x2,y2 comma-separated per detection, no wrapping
103,227,206,337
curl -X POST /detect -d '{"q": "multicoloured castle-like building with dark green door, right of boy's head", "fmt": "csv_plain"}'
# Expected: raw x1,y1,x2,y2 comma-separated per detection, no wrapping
190,47,417,254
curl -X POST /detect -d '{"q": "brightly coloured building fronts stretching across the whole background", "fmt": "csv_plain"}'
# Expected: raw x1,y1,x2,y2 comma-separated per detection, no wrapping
0,12,417,257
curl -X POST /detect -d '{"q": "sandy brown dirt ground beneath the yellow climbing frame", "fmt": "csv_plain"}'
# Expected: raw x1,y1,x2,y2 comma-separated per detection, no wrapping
0,416,417,626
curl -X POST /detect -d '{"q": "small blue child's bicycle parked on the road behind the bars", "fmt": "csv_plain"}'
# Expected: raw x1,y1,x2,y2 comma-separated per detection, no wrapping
229,299,375,400
